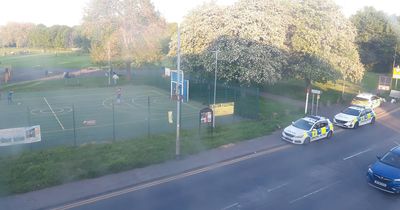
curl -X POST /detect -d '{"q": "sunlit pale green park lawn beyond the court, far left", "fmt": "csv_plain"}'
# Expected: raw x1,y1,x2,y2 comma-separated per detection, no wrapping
0,52,92,70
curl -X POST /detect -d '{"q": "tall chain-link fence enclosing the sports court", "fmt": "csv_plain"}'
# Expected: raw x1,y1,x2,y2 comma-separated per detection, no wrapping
0,71,260,155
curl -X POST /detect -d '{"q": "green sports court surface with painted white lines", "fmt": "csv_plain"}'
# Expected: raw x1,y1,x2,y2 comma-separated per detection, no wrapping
0,85,231,154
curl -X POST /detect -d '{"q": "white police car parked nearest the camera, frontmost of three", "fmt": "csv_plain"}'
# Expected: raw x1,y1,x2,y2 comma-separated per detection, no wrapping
282,116,333,144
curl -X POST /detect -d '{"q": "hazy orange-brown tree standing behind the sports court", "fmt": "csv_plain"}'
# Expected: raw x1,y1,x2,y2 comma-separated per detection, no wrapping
83,0,166,79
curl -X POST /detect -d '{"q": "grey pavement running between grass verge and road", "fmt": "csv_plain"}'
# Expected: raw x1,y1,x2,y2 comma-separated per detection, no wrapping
0,96,396,210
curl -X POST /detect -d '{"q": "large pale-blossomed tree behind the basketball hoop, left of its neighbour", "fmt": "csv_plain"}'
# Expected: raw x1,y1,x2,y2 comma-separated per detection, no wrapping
170,1,287,85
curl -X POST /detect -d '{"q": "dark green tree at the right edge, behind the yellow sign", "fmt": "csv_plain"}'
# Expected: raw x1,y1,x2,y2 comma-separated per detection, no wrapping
350,7,400,72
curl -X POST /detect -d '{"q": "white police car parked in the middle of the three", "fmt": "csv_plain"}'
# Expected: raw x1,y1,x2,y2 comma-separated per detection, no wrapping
333,106,376,128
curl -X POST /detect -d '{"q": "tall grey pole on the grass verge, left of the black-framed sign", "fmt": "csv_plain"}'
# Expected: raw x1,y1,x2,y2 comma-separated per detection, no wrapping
175,25,183,159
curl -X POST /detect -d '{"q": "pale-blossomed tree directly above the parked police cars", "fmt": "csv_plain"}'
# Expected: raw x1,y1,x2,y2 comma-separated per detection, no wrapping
286,0,364,86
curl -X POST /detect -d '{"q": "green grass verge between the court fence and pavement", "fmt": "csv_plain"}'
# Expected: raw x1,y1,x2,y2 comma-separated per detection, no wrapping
0,101,301,196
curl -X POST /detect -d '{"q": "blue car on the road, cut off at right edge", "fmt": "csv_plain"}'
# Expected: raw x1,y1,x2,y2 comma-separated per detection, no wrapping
367,146,400,193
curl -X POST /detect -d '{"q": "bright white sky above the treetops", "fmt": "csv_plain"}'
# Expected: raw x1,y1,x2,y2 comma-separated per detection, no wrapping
0,0,400,26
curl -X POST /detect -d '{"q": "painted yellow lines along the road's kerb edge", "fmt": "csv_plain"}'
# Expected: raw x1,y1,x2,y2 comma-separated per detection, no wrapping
53,144,292,210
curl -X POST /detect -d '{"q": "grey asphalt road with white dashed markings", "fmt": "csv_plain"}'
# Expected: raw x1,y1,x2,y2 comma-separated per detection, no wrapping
54,106,400,210
